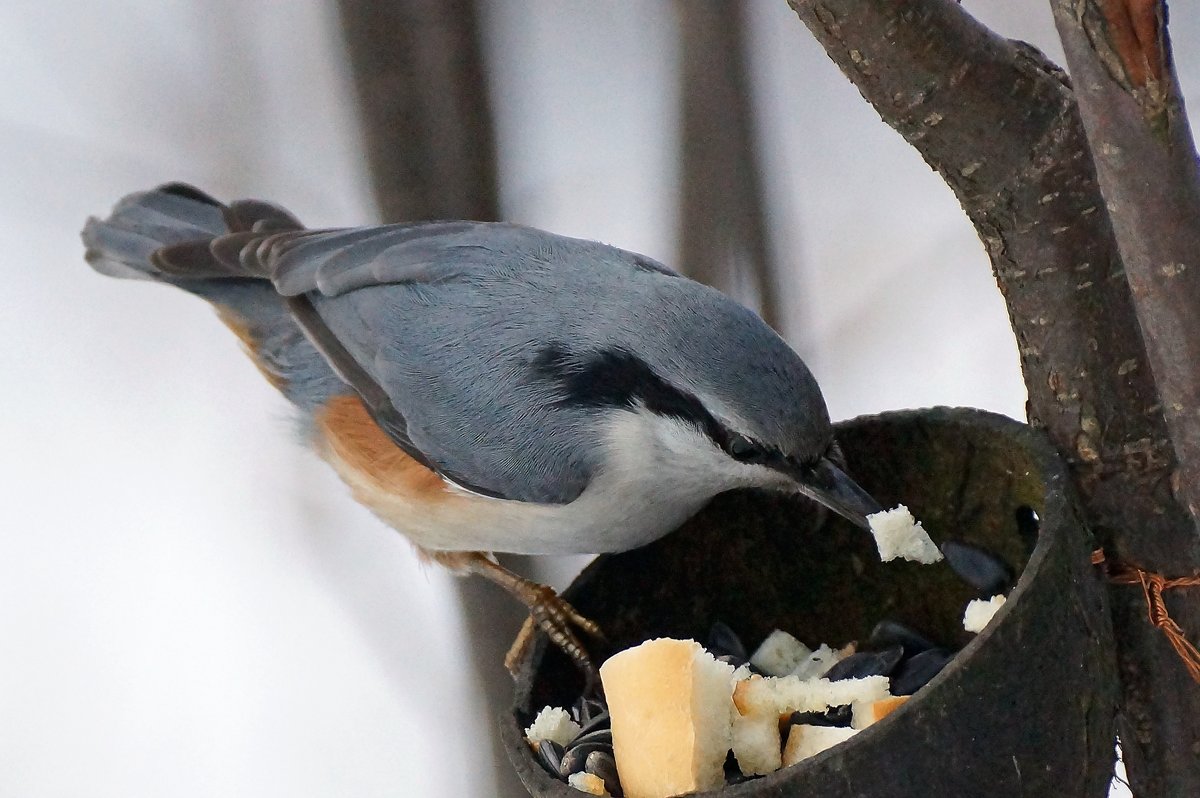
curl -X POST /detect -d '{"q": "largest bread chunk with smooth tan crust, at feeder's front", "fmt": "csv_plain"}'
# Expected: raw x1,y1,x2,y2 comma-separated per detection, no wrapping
600,637,733,798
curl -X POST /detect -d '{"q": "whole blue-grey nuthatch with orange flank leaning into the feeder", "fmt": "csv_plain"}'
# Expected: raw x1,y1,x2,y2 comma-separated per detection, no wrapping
83,184,880,671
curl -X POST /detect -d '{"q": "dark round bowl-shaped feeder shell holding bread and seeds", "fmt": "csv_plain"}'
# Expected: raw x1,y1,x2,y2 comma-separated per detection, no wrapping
502,408,1116,798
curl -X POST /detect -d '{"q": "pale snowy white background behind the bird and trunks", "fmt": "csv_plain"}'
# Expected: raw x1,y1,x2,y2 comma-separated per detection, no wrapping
0,0,1200,798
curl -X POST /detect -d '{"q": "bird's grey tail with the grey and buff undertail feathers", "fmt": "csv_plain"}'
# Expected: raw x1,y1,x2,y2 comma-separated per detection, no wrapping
82,184,346,410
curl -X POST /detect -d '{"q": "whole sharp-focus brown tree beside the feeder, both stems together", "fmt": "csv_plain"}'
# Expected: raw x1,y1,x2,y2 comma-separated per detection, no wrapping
788,0,1200,798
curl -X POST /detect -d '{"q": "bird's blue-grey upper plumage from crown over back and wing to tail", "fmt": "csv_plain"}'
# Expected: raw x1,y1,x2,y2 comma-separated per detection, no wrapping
84,190,832,504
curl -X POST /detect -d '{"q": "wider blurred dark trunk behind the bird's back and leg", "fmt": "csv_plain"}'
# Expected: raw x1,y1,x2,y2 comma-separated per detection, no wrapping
338,0,525,797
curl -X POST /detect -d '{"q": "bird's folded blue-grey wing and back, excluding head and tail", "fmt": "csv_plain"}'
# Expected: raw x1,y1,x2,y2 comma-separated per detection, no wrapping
258,222,677,503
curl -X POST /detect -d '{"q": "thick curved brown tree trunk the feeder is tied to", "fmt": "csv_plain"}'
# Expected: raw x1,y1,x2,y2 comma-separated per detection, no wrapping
788,0,1200,797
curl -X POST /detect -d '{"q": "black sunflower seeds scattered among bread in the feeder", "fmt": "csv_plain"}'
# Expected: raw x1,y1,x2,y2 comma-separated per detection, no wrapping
525,540,1014,798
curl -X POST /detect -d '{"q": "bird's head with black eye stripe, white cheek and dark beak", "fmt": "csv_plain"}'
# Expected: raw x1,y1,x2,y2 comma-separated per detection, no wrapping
539,273,881,528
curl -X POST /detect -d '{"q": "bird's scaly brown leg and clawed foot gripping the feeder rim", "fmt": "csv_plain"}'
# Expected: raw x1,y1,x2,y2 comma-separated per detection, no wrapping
425,551,604,682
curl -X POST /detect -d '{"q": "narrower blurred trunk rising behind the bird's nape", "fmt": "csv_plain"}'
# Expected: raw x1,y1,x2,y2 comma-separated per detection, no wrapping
676,0,780,330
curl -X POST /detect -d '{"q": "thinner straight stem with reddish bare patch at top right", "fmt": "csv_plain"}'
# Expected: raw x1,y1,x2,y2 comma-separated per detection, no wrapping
1051,0,1200,523
